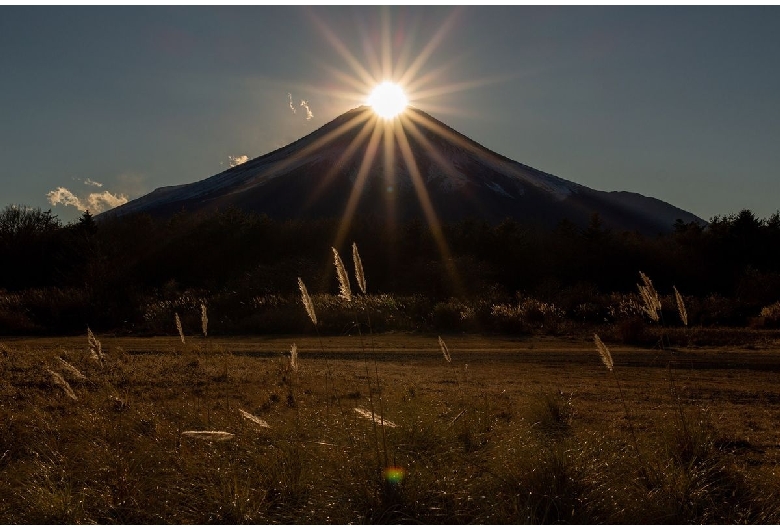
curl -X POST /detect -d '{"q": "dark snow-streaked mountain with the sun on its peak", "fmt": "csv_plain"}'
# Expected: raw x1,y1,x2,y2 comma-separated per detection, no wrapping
102,107,704,234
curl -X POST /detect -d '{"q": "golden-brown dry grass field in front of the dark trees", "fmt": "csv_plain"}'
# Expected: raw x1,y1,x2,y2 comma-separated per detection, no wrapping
0,334,780,524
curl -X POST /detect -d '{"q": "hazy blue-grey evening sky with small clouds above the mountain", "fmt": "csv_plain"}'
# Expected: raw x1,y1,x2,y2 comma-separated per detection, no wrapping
0,6,780,222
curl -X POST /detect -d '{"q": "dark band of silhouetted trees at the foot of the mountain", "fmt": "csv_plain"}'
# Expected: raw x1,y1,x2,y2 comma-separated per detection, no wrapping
0,206,780,333
